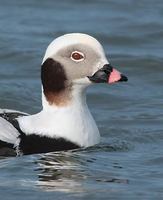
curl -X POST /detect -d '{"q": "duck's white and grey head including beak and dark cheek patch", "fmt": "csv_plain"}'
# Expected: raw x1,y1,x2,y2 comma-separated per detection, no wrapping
41,33,127,107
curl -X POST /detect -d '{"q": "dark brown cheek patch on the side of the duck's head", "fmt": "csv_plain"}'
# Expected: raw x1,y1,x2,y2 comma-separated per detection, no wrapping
41,58,70,106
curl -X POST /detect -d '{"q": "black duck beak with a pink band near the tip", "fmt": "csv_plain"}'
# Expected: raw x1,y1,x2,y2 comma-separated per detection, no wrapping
88,64,128,84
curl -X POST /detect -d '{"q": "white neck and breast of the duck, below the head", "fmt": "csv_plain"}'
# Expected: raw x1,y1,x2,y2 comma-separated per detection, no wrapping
18,85,100,147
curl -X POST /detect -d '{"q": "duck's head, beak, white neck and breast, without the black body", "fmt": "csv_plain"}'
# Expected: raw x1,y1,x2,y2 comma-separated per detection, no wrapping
19,33,127,147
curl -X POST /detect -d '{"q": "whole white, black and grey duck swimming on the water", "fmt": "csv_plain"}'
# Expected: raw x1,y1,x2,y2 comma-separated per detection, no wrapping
0,33,128,156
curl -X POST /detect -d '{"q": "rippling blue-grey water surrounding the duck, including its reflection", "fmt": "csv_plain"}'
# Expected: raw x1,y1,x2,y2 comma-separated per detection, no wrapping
0,0,163,200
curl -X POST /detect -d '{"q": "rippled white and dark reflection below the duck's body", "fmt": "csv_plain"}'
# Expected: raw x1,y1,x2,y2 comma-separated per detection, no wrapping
37,152,86,192
